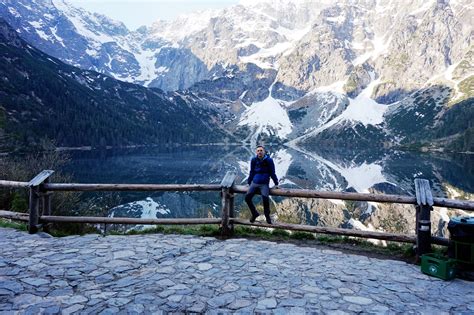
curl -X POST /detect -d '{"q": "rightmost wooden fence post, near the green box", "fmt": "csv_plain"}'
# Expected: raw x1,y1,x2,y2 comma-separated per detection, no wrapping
415,178,434,260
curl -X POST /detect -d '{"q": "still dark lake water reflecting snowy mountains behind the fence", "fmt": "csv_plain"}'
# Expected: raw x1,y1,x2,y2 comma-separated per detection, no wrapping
64,146,474,222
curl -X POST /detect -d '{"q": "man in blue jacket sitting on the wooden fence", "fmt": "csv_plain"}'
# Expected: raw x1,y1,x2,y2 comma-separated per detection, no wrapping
245,145,278,224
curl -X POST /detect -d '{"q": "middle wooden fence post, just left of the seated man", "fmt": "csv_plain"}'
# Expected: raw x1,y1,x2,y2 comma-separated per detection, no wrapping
221,171,237,237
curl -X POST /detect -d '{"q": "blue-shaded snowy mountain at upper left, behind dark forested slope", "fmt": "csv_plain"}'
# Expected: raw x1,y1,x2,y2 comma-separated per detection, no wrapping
0,0,207,90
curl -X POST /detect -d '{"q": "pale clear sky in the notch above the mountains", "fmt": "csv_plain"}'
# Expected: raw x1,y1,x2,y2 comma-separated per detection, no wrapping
65,0,239,30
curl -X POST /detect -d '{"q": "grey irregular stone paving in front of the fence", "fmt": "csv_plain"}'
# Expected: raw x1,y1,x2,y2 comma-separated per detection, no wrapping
0,228,474,314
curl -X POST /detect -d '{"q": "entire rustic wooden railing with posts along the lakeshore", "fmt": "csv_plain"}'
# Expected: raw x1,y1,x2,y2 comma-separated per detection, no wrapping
0,170,474,255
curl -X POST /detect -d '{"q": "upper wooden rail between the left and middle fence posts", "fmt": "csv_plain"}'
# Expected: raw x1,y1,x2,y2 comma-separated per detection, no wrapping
44,183,221,191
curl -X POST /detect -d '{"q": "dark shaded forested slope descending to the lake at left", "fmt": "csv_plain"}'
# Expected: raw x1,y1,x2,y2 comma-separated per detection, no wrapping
0,21,230,152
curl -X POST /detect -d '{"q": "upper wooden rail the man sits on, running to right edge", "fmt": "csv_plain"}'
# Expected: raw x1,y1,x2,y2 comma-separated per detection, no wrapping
232,185,474,211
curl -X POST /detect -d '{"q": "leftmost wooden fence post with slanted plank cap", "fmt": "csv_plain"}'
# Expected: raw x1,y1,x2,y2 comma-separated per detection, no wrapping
28,170,54,234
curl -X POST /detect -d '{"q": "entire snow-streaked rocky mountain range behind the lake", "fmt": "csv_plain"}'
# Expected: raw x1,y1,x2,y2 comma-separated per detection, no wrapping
0,0,474,150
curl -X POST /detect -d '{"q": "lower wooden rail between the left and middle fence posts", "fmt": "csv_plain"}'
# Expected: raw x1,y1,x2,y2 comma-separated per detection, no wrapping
39,216,222,225
